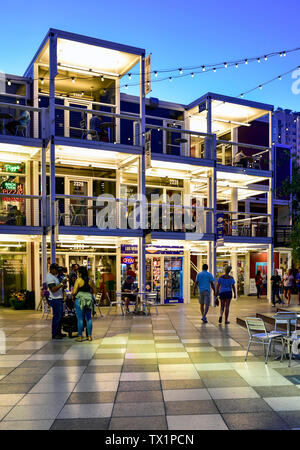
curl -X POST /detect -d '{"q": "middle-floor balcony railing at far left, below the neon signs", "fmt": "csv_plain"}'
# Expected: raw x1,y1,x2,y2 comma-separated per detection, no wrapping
0,194,42,227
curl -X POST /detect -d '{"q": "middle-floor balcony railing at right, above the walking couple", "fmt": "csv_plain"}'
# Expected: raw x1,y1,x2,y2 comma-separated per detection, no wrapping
217,211,271,237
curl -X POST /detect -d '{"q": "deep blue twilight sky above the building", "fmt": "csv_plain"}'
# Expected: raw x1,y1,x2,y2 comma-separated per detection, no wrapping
0,0,300,111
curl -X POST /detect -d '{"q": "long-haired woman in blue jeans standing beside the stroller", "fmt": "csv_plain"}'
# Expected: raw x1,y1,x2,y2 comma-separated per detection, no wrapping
73,266,96,342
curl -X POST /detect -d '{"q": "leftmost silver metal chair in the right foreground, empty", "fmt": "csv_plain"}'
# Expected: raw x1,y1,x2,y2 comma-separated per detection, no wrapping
245,317,284,364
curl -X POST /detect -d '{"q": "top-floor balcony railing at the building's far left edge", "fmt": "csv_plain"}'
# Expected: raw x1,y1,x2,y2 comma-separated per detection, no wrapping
0,103,45,138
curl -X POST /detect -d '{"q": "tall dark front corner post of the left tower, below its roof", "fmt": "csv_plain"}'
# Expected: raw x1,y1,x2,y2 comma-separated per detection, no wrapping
49,33,57,263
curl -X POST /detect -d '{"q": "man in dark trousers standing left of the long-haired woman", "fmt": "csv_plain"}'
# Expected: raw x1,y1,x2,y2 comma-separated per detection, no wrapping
46,263,66,339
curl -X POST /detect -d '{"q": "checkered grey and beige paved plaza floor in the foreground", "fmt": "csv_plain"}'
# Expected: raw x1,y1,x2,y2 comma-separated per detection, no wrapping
0,298,300,430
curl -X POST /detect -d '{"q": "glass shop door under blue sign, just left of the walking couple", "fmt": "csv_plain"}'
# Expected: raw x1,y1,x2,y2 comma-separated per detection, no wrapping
164,256,183,303
